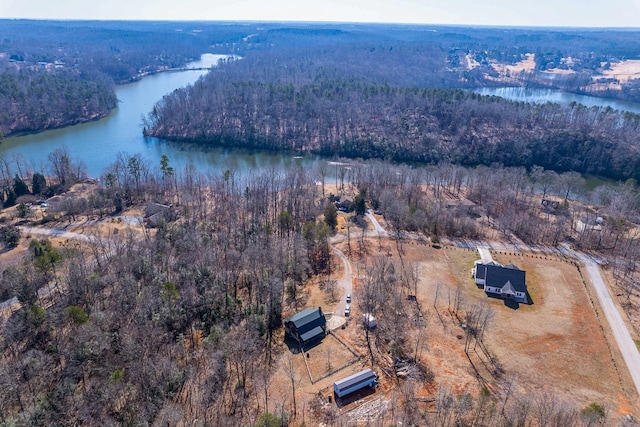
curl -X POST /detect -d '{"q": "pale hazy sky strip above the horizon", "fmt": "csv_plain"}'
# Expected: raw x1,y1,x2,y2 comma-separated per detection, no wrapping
0,0,640,27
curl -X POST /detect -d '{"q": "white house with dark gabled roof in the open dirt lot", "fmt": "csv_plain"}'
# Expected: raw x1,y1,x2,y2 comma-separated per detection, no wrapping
473,261,528,303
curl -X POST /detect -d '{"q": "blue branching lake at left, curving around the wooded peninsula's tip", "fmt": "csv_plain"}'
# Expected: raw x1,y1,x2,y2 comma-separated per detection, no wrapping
0,54,317,177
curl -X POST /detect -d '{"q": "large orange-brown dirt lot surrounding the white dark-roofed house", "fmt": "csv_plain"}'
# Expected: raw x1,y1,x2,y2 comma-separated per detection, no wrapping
405,245,635,420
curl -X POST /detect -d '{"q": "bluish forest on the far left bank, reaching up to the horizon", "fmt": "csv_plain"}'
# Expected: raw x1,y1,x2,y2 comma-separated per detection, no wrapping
0,20,252,137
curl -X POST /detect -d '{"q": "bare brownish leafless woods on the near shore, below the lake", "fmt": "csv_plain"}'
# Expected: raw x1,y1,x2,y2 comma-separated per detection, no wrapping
0,150,640,426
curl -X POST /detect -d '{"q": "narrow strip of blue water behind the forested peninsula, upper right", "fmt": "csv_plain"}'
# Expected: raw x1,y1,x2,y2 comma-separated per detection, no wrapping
473,87,640,114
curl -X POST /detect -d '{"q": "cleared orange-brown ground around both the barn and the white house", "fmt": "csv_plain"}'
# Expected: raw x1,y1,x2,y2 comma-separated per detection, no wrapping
272,238,640,421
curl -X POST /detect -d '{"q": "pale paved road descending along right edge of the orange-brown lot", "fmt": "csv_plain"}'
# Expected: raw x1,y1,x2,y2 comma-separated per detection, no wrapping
567,249,640,395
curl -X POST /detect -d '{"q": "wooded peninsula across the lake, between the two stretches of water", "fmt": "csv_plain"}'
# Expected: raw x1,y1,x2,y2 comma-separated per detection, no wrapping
145,46,640,179
